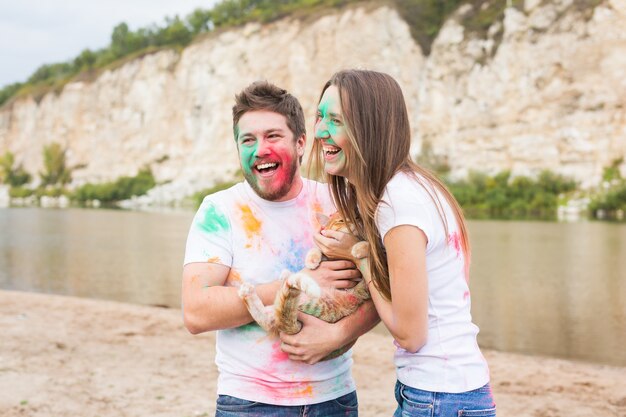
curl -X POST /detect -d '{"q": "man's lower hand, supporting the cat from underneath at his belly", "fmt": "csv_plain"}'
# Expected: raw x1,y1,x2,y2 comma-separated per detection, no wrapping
280,312,350,365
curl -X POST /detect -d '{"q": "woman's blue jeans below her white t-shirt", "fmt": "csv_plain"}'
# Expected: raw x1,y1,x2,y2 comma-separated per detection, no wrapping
393,381,496,417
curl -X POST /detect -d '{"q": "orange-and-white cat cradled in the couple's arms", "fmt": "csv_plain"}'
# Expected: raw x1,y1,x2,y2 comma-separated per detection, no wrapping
239,213,370,360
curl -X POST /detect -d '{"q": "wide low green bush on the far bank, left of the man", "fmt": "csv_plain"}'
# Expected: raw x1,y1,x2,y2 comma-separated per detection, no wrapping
71,167,156,204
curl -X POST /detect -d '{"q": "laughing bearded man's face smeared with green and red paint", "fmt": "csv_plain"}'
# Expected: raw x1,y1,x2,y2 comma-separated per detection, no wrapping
237,110,305,201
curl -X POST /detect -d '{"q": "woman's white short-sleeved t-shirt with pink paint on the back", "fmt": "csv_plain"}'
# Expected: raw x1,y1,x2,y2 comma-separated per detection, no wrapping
376,173,489,393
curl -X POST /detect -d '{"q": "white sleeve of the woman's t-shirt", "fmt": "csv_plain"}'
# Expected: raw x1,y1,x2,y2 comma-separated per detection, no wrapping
376,177,433,243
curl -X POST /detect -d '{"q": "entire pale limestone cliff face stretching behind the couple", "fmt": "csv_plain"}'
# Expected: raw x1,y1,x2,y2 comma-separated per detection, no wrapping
0,0,626,202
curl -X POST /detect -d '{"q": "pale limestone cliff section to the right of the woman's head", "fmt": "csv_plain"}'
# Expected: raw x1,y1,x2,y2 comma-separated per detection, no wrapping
415,0,626,186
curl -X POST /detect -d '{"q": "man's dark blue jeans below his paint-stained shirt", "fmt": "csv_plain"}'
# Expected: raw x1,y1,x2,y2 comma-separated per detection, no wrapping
215,391,359,417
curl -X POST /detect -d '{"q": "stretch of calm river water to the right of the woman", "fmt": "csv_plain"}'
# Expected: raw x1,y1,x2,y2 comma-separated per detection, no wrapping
469,221,626,365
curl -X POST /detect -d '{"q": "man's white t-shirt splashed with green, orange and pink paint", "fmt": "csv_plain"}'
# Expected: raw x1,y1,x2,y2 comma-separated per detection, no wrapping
185,179,355,405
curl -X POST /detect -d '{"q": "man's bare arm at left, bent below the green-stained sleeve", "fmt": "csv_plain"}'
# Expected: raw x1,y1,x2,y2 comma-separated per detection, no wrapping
182,262,280,334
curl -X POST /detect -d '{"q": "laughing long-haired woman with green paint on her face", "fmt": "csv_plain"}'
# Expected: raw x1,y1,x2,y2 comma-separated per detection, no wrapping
312,70,496,417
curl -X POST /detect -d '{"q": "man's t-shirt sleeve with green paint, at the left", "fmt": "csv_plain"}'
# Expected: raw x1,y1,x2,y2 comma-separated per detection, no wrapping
184,196,233,266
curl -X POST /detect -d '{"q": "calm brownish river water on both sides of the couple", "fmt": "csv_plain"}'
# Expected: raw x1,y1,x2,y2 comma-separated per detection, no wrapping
0,209,626,365
